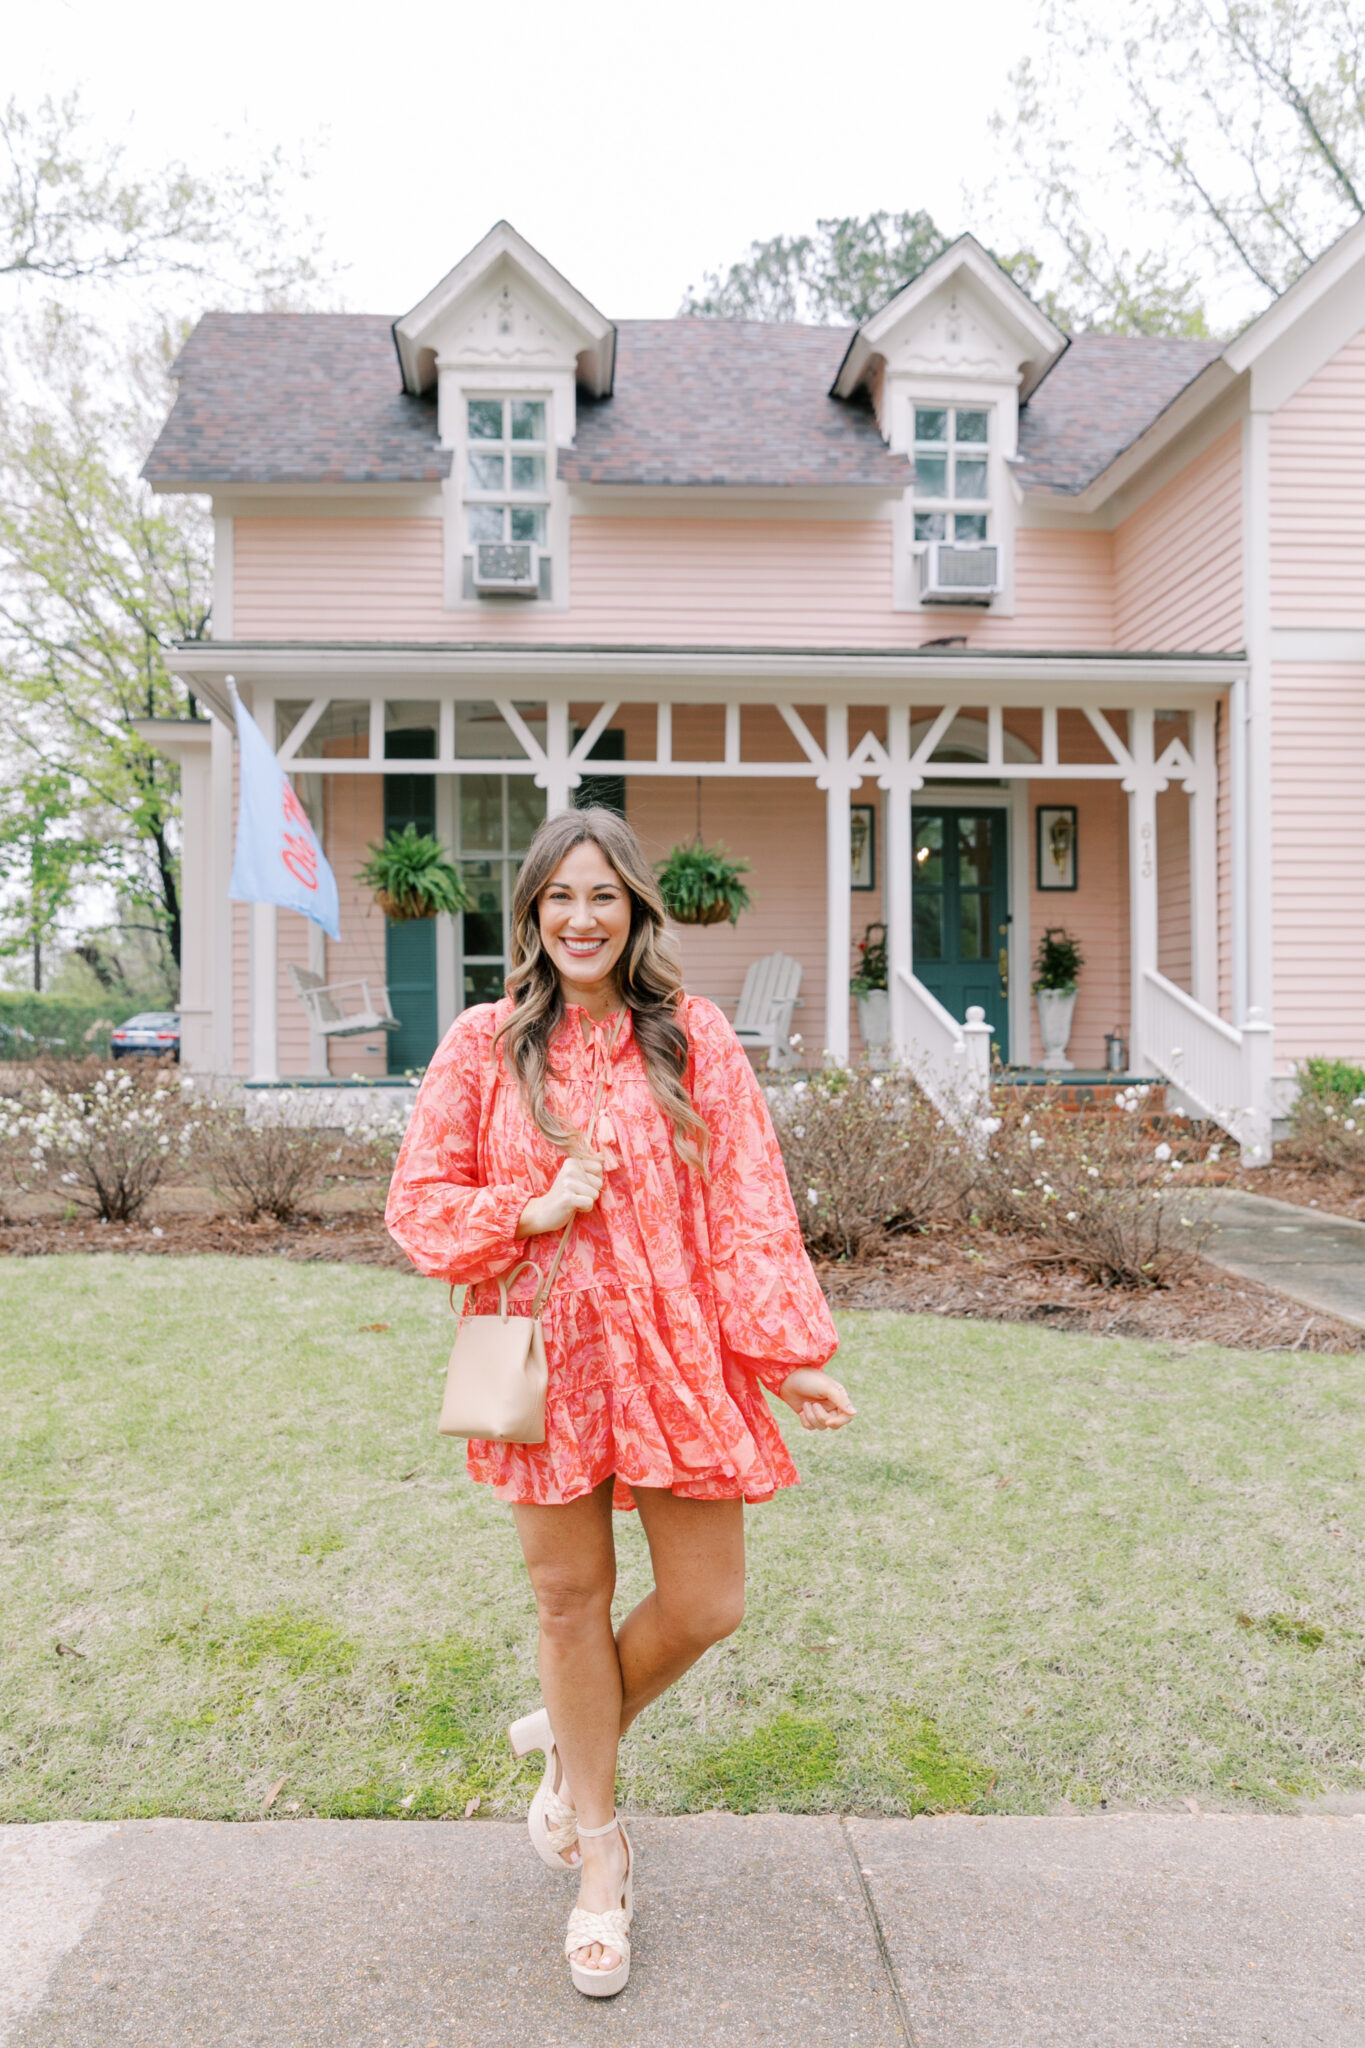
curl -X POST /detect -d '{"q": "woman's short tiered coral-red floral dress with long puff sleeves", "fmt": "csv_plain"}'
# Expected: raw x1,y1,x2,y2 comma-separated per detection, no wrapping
387,997,839,1507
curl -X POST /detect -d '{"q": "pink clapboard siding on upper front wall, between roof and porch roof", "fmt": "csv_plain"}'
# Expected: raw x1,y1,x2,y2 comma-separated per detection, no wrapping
233,516,1113,649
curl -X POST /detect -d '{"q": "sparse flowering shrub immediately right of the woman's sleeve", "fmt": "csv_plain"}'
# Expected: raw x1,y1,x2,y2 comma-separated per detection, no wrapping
769,1067,970,1257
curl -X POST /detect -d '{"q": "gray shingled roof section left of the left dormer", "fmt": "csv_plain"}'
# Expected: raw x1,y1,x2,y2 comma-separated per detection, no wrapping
143,313,450,483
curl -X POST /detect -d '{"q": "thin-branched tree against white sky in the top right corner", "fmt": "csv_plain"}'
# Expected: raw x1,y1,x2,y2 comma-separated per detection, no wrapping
1001,0,1365,334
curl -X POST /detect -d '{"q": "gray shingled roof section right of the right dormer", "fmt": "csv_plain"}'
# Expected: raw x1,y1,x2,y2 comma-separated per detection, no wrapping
1015,334,1222,492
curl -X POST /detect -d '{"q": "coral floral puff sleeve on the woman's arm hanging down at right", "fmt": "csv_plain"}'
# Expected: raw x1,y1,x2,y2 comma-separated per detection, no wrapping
688,997,839,1393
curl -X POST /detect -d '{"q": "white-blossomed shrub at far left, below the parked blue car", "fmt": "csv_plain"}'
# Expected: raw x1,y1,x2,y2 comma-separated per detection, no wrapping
16,1063,199,1223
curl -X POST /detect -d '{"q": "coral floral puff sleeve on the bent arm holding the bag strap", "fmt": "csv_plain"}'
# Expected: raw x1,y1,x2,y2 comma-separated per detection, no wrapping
385,1004,532,1286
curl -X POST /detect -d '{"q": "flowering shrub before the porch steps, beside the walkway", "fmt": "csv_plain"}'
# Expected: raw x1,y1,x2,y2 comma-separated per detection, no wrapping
970,1087,1209,1288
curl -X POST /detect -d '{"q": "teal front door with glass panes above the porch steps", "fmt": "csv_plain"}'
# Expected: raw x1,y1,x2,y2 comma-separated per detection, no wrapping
911,803,1009,1061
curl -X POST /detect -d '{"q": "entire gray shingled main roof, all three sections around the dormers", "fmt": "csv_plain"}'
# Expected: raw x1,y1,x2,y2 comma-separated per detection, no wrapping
143,313,1220,492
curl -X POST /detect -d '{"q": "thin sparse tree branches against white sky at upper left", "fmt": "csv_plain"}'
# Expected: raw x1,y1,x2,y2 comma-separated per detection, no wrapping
0,94,319,305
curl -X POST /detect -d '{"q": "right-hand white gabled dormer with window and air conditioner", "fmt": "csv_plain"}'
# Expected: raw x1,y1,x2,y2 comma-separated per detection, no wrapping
833,236,1066,612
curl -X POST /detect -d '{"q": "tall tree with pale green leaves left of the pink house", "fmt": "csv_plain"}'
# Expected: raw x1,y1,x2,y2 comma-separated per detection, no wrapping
0,317,211,981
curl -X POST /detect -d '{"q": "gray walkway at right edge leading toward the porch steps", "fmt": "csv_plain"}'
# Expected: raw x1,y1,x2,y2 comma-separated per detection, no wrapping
1203,1188,1365,1329
